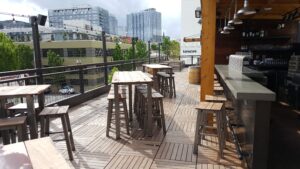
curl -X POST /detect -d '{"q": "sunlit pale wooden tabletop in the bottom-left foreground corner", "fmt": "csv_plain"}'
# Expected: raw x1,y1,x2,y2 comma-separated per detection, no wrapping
0,137,70,169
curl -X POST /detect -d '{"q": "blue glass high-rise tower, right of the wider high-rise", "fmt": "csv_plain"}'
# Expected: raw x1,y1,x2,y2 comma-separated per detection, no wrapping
127,8,161,42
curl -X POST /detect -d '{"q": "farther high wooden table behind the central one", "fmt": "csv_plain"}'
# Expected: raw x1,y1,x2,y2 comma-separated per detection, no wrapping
143,64,172,90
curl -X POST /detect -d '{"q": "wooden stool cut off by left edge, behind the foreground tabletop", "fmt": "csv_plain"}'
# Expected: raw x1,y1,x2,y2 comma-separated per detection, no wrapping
0,116,28,143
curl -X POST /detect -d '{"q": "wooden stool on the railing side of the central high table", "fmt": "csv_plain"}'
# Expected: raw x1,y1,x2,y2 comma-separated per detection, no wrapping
106,89,130,137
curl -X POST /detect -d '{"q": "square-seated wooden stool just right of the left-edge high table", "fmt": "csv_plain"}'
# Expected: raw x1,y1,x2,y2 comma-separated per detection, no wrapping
39,106,75,160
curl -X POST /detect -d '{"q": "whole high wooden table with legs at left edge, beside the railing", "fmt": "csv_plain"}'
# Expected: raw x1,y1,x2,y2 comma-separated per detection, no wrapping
0,85,50,143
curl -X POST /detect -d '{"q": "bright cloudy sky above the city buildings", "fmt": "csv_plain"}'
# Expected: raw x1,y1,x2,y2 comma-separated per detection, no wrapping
0,0,181,39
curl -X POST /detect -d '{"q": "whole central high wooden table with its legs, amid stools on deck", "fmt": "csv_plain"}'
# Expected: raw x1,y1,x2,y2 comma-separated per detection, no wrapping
112,71,153,139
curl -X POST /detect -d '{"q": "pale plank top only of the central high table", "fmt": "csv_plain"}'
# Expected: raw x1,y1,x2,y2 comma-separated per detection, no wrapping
112,71,153,84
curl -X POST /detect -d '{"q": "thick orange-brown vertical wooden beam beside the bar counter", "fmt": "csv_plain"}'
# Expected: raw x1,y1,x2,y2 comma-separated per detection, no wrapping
200,0,217,101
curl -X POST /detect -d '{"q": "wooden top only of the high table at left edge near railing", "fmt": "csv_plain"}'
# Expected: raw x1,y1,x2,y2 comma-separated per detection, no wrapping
0,85,50,97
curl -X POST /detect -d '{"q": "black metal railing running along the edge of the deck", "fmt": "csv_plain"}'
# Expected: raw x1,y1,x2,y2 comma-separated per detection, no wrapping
0,58,164,105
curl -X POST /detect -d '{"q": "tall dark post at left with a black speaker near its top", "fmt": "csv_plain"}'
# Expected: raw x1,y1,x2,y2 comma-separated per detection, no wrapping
30,16,44,84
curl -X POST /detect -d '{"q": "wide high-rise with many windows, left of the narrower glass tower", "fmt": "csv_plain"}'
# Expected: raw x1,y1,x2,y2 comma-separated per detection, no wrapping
48,6,109,32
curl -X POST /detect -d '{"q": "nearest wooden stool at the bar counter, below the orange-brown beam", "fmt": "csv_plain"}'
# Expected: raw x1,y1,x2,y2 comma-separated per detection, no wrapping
194,102,226,157
